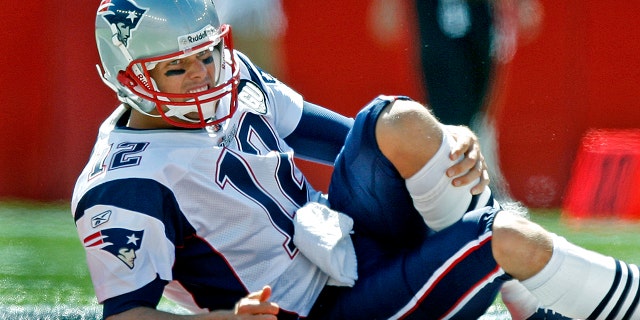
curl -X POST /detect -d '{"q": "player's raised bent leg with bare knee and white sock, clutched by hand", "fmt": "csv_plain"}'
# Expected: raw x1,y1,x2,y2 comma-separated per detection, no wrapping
375,100,493,231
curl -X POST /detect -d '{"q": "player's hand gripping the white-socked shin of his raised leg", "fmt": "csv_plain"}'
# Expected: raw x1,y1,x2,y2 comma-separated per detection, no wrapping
447,126,489,194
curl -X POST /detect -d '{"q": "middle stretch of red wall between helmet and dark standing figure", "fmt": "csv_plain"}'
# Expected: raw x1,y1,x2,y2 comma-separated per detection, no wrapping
280,0,425,191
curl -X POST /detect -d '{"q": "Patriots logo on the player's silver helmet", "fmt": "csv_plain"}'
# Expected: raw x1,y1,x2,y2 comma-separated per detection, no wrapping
98,0,147,47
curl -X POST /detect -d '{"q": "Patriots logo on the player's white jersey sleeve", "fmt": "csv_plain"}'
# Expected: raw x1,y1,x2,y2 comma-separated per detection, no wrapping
84,228,144,269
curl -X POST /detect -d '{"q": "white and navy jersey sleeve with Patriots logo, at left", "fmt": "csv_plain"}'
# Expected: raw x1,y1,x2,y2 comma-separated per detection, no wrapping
75,179,177,304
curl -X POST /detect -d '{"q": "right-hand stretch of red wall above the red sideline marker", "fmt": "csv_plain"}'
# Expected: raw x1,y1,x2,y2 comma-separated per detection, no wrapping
493,0,640,208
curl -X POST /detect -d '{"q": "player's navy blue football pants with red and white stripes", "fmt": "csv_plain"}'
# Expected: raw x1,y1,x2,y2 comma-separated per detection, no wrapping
309,97,510,319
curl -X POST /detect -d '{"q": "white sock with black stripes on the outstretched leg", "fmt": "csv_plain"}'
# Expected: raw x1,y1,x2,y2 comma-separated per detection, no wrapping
522,235,640,319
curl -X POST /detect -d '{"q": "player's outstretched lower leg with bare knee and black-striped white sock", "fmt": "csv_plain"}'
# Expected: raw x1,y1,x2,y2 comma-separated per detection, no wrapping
493,212,640,319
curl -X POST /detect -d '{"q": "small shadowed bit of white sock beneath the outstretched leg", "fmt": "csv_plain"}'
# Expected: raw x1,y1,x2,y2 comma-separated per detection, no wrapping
500,280,540,320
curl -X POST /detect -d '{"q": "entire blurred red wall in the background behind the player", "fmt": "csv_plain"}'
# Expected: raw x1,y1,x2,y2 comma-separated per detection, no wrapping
0,0,640,207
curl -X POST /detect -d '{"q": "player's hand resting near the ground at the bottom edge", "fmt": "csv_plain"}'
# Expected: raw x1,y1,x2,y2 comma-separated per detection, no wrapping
234,286,280,320
